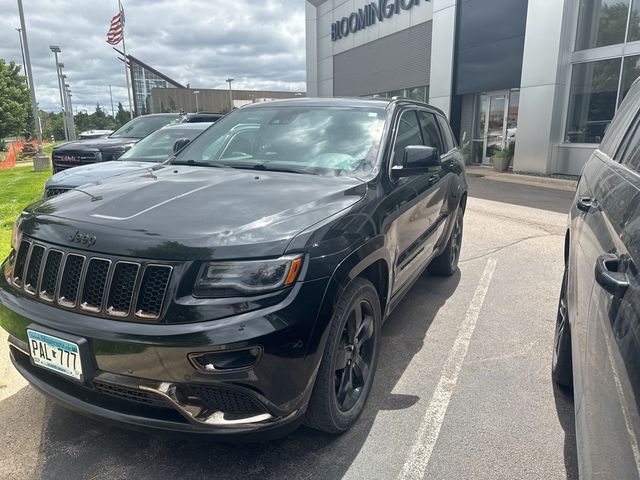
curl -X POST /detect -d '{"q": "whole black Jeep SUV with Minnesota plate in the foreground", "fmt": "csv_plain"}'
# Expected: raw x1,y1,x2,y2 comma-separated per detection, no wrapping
0,99,467,435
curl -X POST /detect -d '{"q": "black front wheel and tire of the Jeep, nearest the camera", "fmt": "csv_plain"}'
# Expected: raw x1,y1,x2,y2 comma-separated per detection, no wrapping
306,278,382,433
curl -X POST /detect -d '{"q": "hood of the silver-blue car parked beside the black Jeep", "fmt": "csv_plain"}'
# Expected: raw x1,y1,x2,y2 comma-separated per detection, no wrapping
45,161,160,188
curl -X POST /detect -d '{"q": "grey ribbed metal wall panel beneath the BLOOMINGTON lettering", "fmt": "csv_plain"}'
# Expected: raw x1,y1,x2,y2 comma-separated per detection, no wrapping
333,21,432,96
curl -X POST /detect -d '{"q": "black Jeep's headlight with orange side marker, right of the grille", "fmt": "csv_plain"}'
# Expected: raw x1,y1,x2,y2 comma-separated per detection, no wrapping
194,255,302,297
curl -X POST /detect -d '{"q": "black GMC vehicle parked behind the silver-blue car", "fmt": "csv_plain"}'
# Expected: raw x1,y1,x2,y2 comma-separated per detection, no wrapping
51,113,181,174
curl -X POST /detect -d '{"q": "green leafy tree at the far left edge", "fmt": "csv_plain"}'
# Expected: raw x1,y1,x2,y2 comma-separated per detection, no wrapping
0,58,31,139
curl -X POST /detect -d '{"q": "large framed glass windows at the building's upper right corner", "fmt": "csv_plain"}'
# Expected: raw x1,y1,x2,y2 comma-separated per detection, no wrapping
565,0,640,144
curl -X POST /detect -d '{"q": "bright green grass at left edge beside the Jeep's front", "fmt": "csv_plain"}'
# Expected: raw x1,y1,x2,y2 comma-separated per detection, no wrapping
0,165,51,262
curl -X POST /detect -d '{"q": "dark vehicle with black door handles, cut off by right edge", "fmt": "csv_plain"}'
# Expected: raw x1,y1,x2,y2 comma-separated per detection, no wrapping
552,81,640,479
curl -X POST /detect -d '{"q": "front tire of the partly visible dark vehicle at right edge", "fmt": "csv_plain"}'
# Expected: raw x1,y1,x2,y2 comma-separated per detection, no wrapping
551,268,573,388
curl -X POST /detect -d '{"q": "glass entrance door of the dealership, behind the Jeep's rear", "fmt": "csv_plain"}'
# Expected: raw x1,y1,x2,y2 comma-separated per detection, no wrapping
472,90,520,165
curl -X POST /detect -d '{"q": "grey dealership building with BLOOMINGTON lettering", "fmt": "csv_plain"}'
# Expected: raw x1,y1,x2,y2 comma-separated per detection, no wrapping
306,0,640,175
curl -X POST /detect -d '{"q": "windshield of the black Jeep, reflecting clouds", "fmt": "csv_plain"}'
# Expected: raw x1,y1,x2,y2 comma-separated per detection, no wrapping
174,106,387,176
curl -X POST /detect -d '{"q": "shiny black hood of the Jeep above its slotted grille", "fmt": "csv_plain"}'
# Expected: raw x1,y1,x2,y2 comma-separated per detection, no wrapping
23,165,367,260
